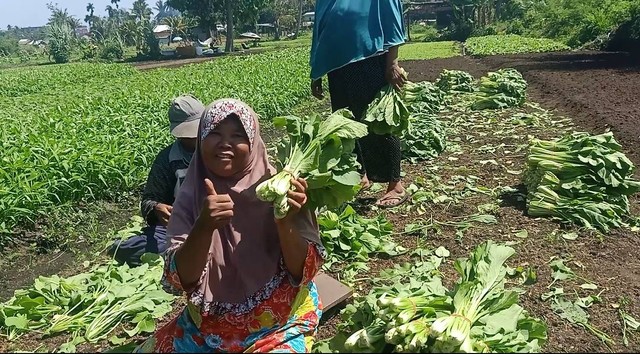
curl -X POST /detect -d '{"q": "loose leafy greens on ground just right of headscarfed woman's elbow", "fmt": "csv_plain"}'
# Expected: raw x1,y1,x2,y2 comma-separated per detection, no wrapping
318,206,406,274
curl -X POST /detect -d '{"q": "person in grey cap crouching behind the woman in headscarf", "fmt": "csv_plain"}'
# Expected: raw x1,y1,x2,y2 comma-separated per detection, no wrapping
107,95,204,266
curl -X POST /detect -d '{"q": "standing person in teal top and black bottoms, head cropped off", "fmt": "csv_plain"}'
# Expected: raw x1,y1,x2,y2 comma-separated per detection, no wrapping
311,0,408,208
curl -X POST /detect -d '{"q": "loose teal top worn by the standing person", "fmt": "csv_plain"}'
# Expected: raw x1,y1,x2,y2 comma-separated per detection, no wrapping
311,0,405,80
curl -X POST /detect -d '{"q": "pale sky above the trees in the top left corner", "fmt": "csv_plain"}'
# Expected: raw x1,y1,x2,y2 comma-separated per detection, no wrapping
0,0,138,29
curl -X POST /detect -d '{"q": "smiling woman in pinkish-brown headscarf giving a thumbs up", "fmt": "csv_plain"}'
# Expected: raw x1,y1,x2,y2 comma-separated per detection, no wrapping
136,99,324,353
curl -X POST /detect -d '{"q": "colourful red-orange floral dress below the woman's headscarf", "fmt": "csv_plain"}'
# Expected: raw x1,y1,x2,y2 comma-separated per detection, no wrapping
135,243,324,353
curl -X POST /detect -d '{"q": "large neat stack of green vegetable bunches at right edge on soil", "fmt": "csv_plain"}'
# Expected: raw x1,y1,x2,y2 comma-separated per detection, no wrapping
524,132,640,232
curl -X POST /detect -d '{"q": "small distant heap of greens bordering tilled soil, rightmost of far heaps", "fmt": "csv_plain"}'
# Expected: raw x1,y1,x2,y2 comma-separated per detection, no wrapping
471,68,527,110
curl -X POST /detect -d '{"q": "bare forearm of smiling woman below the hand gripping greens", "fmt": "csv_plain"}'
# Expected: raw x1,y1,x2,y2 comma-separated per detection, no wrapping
277,222,309,281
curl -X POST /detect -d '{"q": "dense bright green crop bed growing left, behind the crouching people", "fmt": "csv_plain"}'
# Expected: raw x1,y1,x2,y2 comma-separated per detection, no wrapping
0,49,309,239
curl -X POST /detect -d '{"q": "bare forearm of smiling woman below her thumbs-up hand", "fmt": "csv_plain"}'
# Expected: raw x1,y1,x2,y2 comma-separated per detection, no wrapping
175,222,213,289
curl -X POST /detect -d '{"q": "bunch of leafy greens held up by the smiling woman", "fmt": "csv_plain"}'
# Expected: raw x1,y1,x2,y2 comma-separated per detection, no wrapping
256,109,367,218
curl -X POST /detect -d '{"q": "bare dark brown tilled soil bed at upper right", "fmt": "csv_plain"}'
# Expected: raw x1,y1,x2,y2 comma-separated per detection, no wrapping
403,52,640,164
